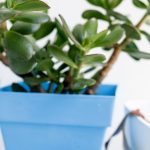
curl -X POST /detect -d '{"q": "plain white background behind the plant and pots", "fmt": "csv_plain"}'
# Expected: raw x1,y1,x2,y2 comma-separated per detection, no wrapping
0,0,150,150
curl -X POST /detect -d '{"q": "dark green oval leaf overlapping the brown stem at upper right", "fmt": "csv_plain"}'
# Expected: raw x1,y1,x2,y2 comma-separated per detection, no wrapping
122,24,141,40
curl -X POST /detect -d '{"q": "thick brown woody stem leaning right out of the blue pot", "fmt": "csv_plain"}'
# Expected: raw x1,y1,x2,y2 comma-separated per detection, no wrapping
85,13,148,94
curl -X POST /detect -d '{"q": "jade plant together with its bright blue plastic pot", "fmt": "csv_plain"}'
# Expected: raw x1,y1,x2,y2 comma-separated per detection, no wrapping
0,0,150,150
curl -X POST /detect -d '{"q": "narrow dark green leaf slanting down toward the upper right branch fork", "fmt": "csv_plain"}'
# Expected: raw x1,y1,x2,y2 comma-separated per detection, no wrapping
108,10,132,24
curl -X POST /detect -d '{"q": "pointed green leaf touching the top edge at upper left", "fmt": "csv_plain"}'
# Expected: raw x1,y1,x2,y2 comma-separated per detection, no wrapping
13,0,50,11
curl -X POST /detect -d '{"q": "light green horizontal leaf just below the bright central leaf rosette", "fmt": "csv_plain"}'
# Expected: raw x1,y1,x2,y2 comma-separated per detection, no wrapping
81,54,106,65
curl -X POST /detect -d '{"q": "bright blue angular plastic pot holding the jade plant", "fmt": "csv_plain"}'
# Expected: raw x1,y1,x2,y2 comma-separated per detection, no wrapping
0,85,116,150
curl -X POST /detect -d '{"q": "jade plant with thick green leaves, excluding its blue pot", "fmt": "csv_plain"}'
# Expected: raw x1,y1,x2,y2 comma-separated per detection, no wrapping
0,0,150,94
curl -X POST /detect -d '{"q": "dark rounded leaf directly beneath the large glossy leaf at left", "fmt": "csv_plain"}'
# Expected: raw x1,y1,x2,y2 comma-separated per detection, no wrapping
8,57,36,74
